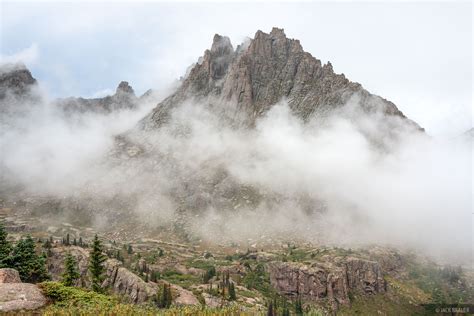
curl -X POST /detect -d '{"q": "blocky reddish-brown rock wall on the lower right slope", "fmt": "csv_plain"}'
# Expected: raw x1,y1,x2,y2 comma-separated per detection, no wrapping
268,258,386,308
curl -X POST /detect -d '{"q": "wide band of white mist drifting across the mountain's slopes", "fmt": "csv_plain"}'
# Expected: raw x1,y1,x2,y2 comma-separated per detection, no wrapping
0,80,472,262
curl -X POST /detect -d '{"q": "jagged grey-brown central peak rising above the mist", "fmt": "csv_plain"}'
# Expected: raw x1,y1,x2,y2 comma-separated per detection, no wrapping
143,28,419,128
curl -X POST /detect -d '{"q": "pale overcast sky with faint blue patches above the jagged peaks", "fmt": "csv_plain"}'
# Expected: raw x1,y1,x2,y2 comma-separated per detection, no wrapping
0,1,473,136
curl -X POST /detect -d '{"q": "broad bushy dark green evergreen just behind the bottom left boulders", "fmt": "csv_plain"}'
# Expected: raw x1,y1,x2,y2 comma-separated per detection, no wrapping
11,235,49,283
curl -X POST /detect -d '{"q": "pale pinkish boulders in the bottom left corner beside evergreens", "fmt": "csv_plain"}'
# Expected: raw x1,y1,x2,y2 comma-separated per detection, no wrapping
0,269,47,313
